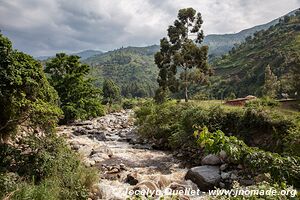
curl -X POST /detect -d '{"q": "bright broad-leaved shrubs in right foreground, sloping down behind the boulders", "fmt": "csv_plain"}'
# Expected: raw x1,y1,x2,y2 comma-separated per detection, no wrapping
194,127,300,187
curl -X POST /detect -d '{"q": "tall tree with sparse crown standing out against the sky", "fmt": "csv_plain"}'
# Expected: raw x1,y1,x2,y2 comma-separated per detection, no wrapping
155,8,209,102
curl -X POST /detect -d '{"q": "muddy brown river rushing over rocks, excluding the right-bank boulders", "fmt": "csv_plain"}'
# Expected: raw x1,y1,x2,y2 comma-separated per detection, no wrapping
58,110,200,200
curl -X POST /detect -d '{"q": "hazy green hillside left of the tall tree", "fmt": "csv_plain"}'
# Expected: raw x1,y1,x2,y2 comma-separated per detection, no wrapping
84,45,159,97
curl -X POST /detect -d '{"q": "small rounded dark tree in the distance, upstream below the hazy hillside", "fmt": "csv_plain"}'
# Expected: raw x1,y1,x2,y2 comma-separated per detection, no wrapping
102,79,121,105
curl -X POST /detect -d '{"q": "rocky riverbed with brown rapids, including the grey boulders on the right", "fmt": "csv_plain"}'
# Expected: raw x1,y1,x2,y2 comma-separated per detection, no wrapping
58,110,254,200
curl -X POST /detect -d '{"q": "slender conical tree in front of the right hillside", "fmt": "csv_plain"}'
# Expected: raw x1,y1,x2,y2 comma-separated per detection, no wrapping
263,65,278,98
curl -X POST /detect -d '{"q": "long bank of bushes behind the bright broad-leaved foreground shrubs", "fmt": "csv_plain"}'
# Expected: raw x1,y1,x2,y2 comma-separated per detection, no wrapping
136,101,300,156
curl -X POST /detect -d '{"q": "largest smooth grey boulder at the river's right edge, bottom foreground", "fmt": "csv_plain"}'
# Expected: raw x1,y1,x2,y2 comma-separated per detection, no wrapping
185,165,221,191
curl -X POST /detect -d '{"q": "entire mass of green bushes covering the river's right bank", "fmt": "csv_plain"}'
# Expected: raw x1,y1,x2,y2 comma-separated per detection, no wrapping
136,100,300,186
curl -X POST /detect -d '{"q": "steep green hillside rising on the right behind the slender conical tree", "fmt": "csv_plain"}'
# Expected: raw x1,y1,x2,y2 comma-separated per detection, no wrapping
206,12,300,98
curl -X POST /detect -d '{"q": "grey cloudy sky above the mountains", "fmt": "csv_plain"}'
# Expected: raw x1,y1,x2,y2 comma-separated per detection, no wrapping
0,0,300,56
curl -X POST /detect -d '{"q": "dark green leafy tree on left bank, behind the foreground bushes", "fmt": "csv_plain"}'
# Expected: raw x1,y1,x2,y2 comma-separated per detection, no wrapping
45,53,104,122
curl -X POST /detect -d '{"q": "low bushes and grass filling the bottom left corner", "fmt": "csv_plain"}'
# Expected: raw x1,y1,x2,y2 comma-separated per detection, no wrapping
0,135,97,199
